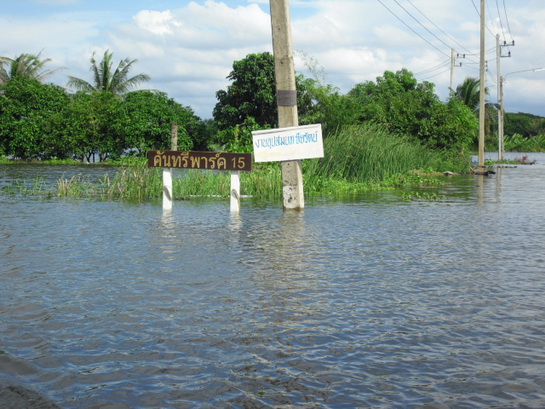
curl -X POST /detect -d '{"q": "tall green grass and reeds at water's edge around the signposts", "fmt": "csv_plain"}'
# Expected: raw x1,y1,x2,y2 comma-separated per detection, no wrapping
2,125,469,202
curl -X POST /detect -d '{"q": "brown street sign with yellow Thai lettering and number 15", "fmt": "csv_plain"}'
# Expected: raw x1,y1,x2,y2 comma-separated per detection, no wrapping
148,150,252,171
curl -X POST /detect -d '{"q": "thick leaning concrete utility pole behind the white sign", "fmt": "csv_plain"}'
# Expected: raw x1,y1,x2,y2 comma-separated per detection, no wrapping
270,0,305,210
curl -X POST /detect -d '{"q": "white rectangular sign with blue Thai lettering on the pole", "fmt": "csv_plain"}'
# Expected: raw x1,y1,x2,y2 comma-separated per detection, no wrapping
252,124,324,162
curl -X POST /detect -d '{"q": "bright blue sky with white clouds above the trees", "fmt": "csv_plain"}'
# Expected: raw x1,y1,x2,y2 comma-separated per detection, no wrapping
0,0,545,119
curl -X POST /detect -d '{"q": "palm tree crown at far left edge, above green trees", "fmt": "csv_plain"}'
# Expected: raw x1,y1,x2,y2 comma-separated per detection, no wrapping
0,51,62,84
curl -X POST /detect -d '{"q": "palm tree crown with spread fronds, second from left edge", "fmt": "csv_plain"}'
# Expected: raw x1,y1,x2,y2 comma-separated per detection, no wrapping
67,50,150,94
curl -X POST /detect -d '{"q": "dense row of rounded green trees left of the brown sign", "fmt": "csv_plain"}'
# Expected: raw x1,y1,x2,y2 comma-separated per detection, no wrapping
0,77,206,161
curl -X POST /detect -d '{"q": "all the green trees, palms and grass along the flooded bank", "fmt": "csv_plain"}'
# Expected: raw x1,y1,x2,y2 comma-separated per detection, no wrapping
0,51,545,202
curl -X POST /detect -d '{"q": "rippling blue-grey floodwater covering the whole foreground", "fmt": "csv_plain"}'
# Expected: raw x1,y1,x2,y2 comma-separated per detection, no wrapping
0,155,545,409
